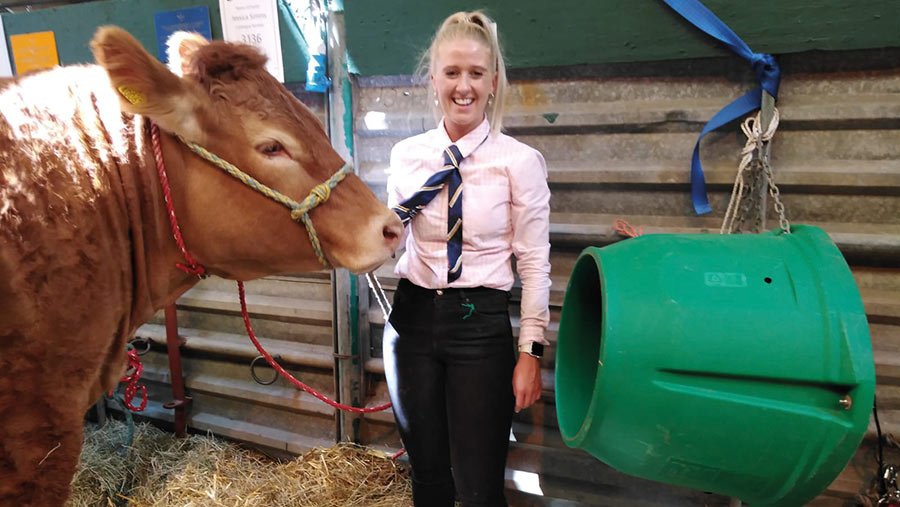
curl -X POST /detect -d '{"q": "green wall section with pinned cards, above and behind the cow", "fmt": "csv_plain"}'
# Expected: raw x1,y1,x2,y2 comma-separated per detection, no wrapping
2,0,309,83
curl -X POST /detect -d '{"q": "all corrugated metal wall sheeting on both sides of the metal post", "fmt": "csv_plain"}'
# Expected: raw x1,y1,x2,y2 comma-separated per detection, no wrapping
125,46,900,505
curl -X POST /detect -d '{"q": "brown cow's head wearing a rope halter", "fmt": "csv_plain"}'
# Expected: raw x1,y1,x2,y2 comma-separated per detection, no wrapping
91,27,402,279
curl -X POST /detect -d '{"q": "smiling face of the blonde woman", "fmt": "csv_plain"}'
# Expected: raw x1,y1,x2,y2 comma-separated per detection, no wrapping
431,37,497,142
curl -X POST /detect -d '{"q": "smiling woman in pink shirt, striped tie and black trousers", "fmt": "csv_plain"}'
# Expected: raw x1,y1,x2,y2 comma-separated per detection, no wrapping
384,8,550,507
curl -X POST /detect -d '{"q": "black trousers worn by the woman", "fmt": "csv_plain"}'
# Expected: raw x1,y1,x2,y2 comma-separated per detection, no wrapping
384,279,515,507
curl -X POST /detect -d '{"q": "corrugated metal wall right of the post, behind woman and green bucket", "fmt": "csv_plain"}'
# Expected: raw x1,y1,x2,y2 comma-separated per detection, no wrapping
356,46,900,505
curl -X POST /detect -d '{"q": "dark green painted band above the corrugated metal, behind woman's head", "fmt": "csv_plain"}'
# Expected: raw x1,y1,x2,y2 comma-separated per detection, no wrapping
345,0,900,76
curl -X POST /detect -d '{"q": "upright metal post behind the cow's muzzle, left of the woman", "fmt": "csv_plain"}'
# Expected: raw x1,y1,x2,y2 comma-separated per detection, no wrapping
326,0,369,442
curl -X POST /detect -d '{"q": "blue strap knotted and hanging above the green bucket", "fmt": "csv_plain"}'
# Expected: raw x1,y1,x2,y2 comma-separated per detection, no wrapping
662,0,781,215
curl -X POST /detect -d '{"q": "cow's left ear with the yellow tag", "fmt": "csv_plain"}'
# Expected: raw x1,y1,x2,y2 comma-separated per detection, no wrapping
91,26,209,142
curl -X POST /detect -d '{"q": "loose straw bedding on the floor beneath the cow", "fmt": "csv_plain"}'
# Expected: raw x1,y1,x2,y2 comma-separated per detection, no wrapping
66,421,412,507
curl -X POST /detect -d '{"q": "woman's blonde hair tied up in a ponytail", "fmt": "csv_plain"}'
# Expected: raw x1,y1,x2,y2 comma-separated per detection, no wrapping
416,11,508,134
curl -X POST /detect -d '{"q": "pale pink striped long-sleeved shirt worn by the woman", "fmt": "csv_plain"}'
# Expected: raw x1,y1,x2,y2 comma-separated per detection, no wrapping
387,119,550,345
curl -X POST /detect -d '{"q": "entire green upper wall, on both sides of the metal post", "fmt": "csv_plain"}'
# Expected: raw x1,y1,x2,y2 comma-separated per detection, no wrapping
2,0,900,82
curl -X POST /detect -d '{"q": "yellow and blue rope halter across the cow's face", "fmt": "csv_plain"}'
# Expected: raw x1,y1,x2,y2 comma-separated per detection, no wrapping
178,136,353,268
